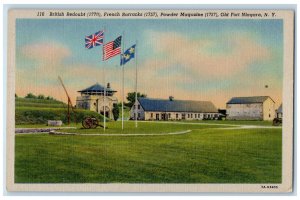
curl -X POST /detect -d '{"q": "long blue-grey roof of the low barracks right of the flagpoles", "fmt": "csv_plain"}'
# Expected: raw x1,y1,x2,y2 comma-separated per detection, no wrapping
138,98,218,113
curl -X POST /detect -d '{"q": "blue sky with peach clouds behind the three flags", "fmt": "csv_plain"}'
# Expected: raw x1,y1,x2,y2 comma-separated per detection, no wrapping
16,19,283,108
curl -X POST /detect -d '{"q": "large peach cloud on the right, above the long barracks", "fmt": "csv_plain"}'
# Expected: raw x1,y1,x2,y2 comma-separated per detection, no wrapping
147,31,270,78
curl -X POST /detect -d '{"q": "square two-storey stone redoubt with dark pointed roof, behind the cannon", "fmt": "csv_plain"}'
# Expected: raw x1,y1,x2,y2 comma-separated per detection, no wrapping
76,83,118,118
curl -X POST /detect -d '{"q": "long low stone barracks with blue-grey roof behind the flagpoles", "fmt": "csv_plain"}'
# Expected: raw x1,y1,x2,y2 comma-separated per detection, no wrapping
130,97,220,120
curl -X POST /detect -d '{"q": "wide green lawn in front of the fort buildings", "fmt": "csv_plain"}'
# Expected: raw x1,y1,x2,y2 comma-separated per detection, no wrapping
15,121,282,183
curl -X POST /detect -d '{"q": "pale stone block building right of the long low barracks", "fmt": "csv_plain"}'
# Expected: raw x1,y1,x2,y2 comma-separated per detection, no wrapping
226,96,275,120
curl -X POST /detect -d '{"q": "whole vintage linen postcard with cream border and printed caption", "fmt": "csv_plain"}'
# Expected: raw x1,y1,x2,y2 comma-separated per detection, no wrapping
6,9,294,193
